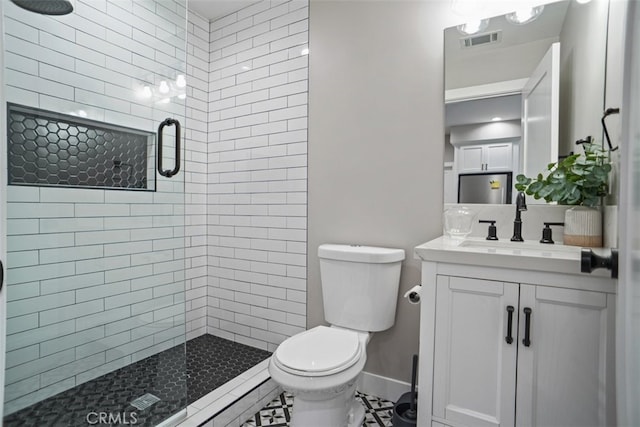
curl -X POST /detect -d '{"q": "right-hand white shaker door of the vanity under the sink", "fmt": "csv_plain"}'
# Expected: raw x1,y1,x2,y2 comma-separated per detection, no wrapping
516,285,616,427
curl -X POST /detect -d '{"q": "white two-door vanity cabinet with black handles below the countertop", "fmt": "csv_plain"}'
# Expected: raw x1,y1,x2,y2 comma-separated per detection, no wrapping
418,262,615,427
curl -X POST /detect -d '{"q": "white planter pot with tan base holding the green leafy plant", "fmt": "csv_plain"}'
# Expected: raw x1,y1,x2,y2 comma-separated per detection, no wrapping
563,206,602,248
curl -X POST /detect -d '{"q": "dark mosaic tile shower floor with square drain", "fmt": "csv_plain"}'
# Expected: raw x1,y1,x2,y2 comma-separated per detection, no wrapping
3,335,271,427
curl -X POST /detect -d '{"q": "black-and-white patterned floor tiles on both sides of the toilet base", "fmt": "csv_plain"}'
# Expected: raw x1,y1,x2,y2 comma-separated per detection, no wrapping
241,392,393,427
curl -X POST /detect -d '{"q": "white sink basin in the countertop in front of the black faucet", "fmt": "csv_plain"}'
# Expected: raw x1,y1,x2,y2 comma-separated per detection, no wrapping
459,239,580,258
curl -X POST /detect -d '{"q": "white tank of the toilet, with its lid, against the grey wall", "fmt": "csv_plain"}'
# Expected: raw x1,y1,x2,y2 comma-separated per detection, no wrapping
318,244,404,332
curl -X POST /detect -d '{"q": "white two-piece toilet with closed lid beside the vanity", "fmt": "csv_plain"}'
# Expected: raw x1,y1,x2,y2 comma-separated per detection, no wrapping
269,244,405,427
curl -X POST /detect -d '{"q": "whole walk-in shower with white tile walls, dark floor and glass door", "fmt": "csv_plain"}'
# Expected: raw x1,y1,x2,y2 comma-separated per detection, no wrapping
0,0,309,427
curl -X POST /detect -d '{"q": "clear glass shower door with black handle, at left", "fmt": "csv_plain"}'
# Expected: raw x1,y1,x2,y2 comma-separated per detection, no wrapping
1,0,187,426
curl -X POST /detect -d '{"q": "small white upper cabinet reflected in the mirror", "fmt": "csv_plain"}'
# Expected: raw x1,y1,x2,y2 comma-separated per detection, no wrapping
456,142,513,173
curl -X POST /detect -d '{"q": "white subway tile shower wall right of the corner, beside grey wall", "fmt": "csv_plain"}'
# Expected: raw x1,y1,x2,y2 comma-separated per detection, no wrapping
206,0,309,351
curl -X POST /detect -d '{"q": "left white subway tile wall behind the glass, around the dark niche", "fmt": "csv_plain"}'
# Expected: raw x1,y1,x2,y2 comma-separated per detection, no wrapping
4,0,192,414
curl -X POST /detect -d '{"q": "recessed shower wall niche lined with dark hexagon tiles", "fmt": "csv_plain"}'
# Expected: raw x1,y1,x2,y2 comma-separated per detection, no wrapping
7,104,155,190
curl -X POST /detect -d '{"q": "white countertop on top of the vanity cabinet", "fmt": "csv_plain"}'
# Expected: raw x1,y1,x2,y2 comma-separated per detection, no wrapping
415,236,611,277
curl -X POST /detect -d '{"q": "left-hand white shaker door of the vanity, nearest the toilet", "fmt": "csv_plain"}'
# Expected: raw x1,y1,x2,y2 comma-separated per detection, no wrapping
433,276,518,427
